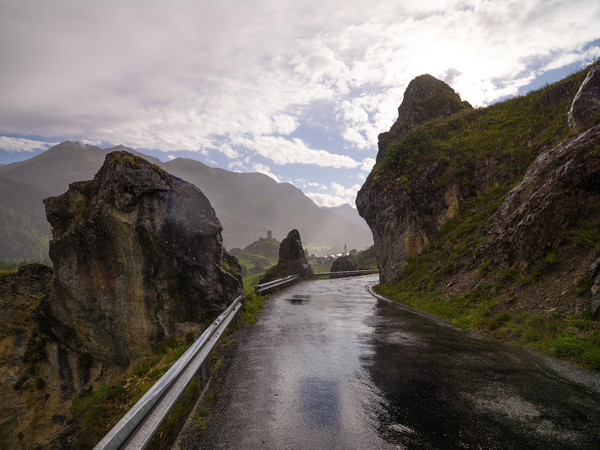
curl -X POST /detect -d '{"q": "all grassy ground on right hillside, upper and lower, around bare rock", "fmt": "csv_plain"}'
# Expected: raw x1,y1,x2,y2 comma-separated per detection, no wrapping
373,66,600,371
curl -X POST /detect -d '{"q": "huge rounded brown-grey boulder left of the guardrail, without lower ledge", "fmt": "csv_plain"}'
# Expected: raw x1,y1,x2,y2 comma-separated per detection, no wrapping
37,151,242,365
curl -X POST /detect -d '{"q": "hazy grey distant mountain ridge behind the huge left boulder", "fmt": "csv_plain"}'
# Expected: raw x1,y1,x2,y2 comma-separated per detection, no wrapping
0,141,372,261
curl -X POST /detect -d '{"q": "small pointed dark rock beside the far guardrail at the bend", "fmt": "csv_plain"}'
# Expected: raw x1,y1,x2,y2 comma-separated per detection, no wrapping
260,229,315,283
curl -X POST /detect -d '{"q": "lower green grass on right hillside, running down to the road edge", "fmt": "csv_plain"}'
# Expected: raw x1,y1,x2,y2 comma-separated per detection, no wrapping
376,181,600,371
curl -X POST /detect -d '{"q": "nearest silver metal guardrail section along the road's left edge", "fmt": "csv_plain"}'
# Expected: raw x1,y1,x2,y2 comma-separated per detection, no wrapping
94,295,243,450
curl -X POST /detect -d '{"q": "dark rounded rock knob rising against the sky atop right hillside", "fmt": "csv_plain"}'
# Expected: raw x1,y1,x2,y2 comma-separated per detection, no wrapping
377,74,471,162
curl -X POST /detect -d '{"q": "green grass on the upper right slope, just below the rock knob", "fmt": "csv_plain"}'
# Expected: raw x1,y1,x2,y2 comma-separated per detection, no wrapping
375,71,585,194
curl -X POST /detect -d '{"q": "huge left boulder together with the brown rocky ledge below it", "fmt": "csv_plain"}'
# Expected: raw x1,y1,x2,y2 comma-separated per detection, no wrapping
0,151,242,448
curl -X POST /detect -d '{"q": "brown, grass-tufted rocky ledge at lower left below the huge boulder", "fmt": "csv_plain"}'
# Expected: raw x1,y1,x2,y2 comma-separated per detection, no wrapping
0,264,125,448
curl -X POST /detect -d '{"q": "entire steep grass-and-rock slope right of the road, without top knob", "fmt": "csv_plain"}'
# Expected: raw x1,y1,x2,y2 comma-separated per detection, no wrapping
357,65,600,370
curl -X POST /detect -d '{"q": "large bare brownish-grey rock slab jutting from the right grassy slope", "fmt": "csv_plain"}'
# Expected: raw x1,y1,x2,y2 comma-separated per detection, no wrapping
478,125,600,263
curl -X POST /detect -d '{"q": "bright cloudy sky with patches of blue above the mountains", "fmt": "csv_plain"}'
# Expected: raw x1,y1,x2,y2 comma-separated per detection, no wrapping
0,0,600,205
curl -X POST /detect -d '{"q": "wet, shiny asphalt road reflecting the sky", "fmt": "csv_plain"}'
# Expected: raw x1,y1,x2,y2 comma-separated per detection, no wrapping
196,276,600,449
